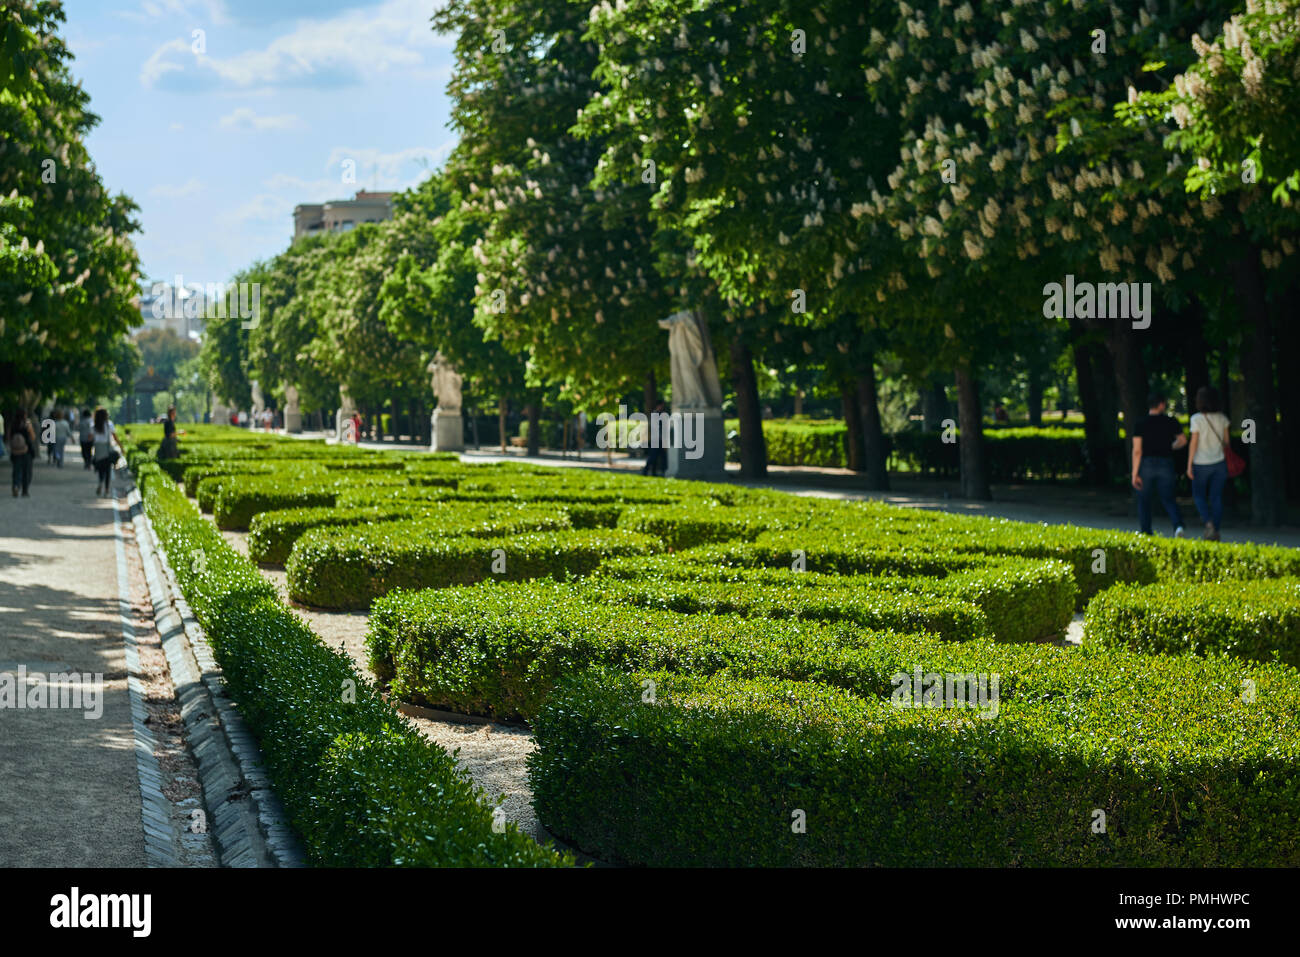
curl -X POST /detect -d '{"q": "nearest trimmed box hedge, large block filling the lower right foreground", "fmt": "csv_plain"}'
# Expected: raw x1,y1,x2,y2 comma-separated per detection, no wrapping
528,655,1300,867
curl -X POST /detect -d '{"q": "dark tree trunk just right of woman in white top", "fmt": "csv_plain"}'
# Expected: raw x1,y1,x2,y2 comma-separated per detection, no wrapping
1232,248,1283,525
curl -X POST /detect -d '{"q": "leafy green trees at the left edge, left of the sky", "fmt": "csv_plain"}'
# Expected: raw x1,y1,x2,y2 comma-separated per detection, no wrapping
0,3,139,410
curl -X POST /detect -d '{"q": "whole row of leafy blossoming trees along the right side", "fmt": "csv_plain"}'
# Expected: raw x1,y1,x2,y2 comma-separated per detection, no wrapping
204,0,1300,521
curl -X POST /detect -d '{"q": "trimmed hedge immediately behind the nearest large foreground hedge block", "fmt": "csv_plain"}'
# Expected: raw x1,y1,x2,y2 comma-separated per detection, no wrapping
367,581,961,718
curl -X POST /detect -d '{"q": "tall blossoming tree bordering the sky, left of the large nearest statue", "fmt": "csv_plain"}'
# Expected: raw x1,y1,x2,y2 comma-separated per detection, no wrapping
434,0,675,436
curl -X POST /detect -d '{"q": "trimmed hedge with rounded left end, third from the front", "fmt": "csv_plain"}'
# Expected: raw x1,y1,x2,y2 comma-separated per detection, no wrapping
285,520,660,609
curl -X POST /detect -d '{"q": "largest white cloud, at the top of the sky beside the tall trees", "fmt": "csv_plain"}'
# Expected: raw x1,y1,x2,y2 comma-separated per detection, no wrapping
140,0,452,90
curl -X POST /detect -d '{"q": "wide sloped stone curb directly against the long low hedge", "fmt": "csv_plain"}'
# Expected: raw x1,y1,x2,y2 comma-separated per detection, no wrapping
127,475,306,867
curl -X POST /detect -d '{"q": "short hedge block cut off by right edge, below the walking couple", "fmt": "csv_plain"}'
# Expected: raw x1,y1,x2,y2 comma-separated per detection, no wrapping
1084,579,1300,667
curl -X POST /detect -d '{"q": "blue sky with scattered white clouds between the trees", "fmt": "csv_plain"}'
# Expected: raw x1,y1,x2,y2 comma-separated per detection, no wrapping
64,0,455,283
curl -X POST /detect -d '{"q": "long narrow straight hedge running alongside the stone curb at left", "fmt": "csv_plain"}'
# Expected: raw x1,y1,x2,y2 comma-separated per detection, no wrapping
129,464,572,867
